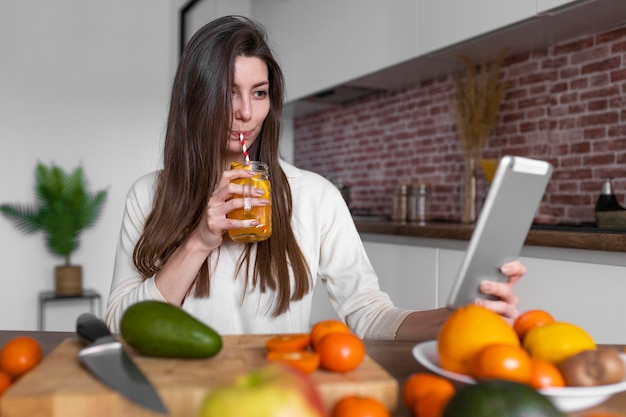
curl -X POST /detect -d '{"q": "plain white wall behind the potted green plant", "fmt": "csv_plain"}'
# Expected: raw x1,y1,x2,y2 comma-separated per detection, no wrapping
0,0,182,331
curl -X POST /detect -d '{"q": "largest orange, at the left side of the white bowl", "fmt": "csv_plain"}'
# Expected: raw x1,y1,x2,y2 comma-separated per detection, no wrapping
437,304,520,375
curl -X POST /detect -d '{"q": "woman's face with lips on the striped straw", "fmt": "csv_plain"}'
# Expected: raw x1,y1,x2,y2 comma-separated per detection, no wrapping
228,56,270,162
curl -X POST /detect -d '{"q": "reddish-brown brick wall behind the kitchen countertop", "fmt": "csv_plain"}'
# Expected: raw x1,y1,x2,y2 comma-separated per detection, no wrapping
294,28,626,223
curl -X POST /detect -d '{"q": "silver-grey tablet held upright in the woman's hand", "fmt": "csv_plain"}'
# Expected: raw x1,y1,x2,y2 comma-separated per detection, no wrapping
447,156,552,309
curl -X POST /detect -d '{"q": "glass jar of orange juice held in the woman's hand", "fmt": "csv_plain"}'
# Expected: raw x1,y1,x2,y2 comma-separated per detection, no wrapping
227,161,272,242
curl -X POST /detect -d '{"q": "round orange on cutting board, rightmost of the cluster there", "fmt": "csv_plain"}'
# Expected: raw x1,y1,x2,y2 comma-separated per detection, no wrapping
317,333,365,372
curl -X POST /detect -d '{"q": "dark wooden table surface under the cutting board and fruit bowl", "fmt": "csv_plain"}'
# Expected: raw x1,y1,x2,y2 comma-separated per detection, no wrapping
0,331,626,417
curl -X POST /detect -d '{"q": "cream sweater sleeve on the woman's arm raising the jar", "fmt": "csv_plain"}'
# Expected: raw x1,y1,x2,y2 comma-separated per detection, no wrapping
105,173,165,333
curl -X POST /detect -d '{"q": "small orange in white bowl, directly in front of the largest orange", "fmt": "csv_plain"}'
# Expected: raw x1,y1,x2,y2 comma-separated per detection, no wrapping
472,344,532,384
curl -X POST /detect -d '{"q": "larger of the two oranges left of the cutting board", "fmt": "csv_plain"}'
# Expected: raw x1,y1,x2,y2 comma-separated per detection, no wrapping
0,336,43,379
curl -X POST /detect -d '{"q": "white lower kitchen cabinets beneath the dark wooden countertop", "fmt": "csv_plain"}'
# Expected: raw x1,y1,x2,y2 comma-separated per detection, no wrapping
362,234,626,344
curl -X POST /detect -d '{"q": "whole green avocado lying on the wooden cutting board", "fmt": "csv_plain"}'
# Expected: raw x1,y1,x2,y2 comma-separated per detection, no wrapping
120,301,222,358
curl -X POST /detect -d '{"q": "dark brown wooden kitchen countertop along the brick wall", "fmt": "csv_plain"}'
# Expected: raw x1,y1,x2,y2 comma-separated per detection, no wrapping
354,216,626,252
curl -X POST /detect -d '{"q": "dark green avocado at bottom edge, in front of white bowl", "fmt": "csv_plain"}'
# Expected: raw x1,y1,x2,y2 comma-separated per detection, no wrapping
442,379,564,417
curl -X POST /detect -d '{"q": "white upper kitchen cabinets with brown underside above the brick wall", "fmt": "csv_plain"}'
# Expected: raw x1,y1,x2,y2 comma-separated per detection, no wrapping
187,0,624,106
